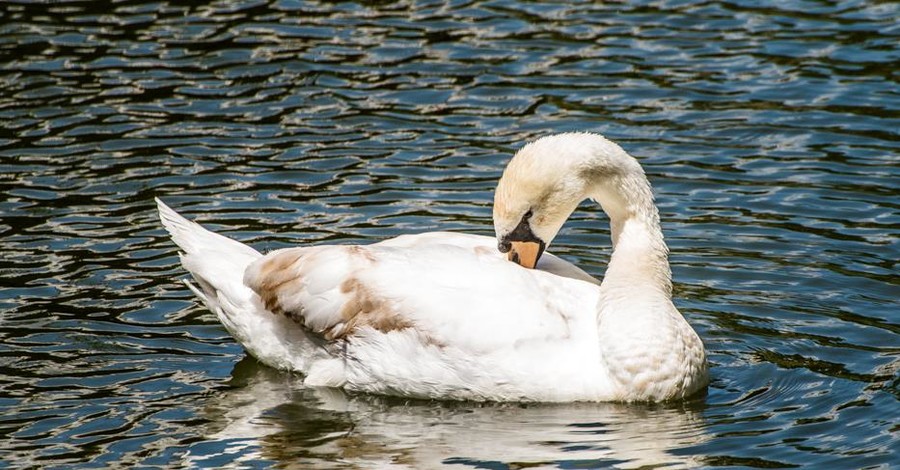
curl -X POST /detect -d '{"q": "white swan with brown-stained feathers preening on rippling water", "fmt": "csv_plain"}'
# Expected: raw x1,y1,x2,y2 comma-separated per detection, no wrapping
156,133,709,402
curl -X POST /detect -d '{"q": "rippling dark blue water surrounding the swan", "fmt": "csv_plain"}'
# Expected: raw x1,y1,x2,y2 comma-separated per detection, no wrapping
0,0,900,469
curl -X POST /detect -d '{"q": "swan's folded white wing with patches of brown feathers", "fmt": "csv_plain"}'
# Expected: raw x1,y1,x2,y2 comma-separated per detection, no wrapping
244,233,597,352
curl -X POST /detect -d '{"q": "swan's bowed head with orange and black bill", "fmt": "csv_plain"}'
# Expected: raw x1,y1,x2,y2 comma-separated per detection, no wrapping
494,134,614,268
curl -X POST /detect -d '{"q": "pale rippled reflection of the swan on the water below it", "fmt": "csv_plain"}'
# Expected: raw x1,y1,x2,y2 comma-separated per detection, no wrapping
188,359,707,469
